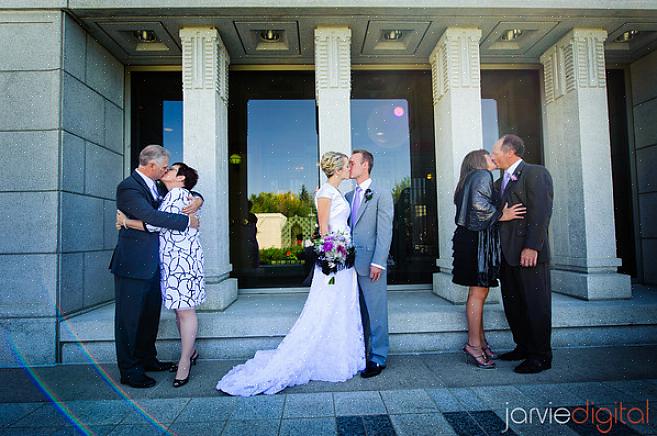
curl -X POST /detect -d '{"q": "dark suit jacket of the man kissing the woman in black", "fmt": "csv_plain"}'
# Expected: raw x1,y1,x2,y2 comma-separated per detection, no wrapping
495,161,554,266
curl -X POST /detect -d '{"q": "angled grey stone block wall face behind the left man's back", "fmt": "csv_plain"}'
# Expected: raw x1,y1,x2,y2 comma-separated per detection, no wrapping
59,12,124,314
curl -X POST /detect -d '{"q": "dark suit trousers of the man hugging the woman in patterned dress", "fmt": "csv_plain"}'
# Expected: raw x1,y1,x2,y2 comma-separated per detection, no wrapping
114,271,162,377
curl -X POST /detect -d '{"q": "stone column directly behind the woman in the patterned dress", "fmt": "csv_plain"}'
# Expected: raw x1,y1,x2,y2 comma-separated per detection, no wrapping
180,27,237,310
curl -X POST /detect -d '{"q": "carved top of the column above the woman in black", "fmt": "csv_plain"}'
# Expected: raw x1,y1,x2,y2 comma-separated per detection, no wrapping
429,27,481,104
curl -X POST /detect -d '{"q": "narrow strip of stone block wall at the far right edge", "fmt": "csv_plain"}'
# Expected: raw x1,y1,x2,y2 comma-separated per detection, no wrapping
628,51,657,285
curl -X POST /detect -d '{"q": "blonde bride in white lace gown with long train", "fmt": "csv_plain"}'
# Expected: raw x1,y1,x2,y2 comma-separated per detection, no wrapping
217,152,365,397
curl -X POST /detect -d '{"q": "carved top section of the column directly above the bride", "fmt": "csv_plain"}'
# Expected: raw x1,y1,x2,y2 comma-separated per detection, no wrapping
315,27,351,101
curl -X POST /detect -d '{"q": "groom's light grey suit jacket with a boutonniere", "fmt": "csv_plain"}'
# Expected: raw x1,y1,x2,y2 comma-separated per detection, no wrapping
345,182,393,276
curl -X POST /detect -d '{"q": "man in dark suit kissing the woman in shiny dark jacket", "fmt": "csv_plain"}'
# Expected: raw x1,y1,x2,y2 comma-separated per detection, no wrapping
491,134,554,374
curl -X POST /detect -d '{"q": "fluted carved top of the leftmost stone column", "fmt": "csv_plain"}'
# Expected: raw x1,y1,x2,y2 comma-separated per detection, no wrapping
180,27,230,101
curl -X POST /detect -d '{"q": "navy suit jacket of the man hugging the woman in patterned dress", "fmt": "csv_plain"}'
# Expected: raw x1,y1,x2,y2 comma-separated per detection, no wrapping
110,171,189,280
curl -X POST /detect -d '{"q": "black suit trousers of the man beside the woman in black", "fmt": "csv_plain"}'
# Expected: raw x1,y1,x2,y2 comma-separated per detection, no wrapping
500,259,552,361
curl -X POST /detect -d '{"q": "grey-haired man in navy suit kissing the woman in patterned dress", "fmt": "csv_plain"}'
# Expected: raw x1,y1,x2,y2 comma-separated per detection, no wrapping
110,145,198,388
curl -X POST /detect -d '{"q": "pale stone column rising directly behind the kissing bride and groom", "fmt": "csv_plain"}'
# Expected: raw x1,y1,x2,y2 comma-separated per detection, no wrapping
315,27,351,189
